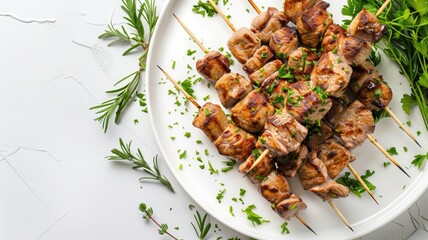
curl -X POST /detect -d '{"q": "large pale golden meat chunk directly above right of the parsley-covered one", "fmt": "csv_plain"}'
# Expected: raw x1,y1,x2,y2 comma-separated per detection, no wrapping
311,52,352,97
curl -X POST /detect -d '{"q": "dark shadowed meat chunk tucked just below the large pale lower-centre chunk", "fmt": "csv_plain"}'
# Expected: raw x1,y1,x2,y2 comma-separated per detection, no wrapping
276,144,308,177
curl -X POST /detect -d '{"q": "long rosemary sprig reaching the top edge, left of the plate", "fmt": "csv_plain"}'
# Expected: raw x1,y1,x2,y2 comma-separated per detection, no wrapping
91,0,158,132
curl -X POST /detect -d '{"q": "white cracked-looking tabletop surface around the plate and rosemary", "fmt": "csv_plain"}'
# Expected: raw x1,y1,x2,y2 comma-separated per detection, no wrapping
0,0,428,240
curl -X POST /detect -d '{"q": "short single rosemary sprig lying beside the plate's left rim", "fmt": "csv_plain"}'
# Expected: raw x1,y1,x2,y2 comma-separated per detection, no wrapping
107,138,174,192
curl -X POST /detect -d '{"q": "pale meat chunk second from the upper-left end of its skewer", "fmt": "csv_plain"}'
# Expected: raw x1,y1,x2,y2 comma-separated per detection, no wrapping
215,73,253,108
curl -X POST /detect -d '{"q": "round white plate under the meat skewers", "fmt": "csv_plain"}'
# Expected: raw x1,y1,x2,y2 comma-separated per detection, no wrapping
146,1,428,239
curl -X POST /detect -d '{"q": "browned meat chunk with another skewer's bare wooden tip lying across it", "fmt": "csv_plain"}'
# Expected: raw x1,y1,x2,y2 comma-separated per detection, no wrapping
239,148,274,183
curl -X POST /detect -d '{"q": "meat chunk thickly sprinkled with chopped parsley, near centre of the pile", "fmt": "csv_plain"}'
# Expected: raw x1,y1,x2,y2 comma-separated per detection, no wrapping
286,81,332,124
